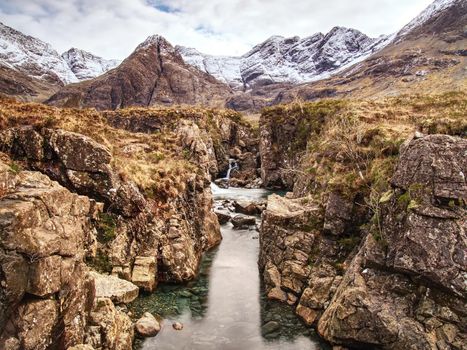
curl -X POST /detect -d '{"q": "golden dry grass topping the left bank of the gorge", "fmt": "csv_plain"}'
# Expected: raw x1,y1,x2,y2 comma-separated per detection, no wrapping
0,99,246,199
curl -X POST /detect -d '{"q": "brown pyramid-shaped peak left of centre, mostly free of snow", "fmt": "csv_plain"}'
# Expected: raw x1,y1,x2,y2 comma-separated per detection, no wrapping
47,35,231,110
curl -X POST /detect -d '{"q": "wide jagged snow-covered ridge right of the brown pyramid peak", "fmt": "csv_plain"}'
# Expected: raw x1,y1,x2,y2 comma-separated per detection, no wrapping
177,27,392,88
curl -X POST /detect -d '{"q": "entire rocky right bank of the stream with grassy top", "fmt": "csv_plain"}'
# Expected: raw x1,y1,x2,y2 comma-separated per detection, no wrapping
259,94,467,349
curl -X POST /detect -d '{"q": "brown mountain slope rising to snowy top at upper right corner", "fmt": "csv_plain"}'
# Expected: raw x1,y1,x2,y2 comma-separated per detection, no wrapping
256,0,467,105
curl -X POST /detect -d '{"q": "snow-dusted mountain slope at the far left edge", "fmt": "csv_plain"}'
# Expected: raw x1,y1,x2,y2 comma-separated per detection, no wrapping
0,23,78,85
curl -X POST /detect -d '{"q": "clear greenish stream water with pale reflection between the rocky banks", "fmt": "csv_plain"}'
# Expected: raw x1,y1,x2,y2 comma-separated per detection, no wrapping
131,185,327,350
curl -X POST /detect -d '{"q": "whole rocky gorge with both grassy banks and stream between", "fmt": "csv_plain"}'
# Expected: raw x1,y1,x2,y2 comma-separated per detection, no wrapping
0,90,467,349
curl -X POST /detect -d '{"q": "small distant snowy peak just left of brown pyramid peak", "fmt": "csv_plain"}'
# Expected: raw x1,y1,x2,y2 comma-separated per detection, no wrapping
62,48,121,81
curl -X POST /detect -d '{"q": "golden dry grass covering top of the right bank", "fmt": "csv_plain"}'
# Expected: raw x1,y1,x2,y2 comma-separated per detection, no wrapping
263,93,467,202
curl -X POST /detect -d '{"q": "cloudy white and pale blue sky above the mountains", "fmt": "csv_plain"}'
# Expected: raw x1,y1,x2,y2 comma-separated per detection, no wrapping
0,0,432,59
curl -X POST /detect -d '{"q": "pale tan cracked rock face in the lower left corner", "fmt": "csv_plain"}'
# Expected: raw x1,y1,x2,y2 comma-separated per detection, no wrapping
0,157,98,350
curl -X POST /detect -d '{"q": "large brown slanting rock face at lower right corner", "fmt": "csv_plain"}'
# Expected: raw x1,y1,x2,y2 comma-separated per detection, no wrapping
318,135,467,349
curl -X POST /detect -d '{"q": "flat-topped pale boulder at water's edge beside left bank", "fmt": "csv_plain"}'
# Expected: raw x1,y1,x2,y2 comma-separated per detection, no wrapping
91,272,139,304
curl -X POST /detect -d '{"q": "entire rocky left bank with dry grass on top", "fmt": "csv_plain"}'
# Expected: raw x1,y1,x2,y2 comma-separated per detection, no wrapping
0,101,256,349
